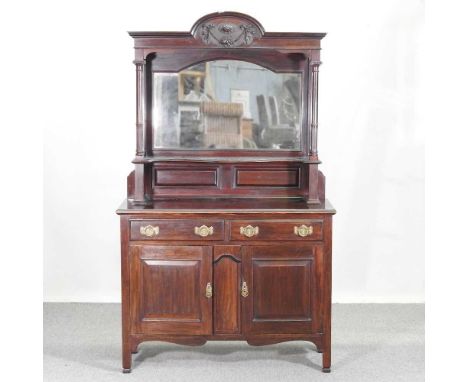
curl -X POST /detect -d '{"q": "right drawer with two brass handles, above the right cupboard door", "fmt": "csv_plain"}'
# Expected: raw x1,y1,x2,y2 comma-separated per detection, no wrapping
230,219,323,240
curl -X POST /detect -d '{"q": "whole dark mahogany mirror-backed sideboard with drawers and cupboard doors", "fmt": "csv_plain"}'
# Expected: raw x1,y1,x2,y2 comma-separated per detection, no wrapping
117,12,335,372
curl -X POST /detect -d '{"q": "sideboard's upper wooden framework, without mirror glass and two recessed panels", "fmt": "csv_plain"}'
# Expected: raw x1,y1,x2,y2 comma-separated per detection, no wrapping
127,12,326,204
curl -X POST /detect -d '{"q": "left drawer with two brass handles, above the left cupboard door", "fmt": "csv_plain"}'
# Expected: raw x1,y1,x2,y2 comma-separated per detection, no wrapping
130,219,224,240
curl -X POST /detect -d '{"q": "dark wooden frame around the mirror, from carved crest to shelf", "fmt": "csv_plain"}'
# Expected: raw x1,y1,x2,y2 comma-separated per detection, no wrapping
129,12,326,160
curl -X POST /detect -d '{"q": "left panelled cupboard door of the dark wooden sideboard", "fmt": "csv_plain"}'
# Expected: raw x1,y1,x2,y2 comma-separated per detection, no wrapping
130,245,213,335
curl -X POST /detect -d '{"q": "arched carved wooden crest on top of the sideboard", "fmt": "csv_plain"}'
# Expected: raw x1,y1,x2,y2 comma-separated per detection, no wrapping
192,12,264,48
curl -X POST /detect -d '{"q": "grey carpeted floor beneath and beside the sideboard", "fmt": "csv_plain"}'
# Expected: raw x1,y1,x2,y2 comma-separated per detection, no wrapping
44,303,424,382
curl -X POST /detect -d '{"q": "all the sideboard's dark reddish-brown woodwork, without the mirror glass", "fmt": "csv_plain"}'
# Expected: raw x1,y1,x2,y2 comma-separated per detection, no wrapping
117,12,336,372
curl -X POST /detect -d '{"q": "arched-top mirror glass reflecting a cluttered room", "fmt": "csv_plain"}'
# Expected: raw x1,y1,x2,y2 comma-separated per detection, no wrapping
153,60,302,150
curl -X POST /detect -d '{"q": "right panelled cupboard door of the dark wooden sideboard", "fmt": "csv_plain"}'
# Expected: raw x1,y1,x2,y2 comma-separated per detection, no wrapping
241,244,318,335
